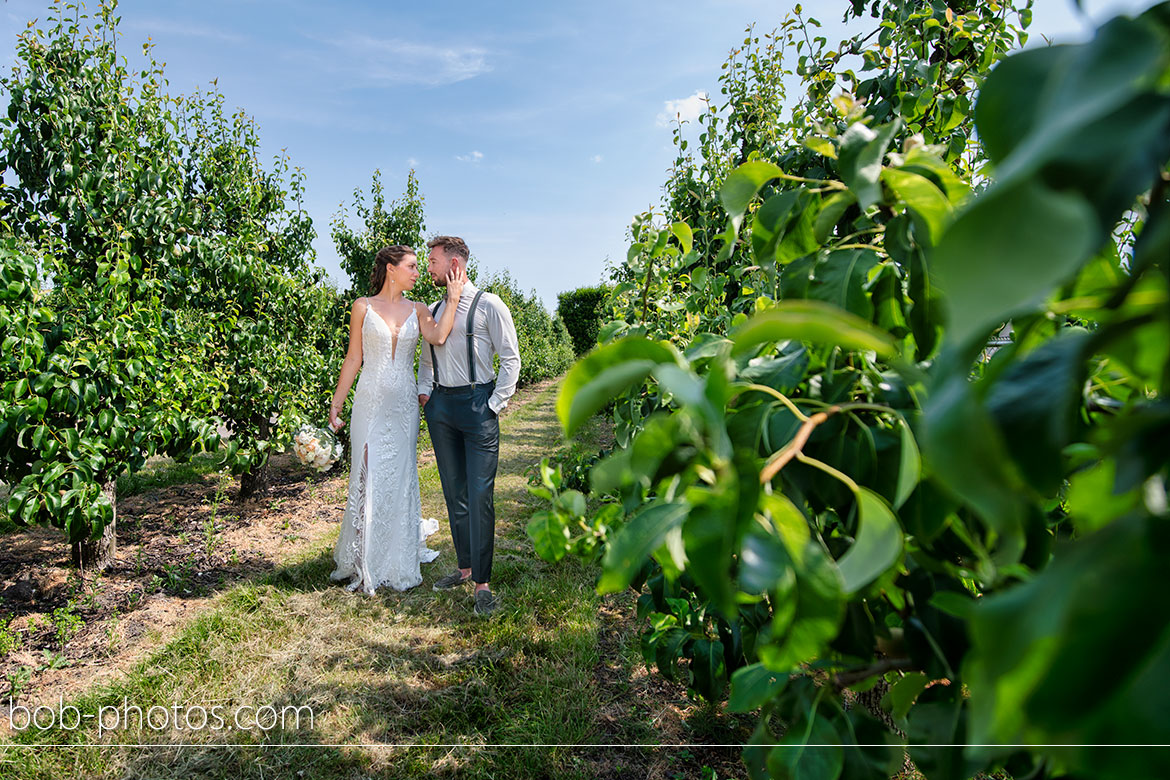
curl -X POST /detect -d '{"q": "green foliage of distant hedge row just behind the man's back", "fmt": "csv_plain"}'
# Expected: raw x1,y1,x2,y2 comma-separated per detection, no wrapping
479,270,573,387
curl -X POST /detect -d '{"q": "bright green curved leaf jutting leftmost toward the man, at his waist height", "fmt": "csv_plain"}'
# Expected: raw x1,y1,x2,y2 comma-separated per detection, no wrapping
557,336,680,436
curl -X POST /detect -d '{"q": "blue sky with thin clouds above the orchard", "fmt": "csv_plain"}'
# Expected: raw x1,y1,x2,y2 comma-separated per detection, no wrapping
0,0,1152,312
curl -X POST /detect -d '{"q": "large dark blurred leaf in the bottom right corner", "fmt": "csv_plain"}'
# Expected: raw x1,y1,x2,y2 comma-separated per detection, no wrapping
965,517,1170,753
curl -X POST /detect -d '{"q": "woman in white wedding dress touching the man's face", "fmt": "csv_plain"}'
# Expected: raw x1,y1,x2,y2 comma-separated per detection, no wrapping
329,244,467,594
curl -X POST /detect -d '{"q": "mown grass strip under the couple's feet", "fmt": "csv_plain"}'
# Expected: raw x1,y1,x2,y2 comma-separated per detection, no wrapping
0,387,627,778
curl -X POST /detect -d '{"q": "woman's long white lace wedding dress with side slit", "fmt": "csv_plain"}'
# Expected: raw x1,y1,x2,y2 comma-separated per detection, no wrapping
330,306,439,594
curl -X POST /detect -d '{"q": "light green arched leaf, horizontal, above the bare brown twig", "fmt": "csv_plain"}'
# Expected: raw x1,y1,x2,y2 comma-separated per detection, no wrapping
731,301,896,358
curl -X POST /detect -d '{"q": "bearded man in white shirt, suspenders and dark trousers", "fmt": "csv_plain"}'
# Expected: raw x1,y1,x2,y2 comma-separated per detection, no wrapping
419,235,519,615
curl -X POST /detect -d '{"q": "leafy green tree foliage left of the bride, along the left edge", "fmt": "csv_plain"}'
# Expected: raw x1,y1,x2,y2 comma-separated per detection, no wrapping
0,2,343,541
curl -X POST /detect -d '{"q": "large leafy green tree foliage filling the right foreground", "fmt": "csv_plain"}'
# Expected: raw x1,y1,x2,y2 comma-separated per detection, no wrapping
529,1,1170,780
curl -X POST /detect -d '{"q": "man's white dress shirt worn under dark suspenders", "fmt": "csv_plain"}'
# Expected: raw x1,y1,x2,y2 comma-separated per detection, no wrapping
419,281,519,414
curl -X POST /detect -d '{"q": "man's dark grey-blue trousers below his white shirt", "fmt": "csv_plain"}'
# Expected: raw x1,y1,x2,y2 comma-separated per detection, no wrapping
422,382,500,582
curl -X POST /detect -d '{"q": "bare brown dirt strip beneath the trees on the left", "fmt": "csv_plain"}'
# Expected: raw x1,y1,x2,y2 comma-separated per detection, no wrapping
0,380,553,733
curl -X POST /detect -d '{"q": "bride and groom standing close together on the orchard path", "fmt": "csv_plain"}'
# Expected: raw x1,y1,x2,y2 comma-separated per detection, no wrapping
329,236,519,615
